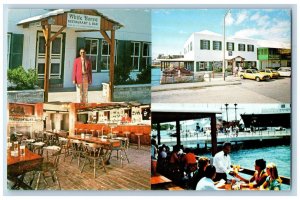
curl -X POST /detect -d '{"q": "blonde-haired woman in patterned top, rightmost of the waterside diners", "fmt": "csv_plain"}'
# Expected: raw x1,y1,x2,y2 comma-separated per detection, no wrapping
260,163,282,190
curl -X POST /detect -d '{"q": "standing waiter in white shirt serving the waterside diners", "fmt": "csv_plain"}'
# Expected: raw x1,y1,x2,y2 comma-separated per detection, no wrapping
213,142,231,181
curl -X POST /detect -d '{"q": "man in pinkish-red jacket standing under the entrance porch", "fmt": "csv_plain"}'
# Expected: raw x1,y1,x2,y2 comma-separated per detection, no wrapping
72,48,92,103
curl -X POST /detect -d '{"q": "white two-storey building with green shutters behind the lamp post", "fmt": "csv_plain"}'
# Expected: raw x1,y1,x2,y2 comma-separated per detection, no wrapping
183,30,290,72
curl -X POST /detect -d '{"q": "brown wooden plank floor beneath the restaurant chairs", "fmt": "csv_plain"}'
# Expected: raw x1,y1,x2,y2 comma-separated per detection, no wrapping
12,146,151,190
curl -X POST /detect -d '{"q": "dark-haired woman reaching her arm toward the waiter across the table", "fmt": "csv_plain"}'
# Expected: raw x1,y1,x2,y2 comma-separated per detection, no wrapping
234,159,268,188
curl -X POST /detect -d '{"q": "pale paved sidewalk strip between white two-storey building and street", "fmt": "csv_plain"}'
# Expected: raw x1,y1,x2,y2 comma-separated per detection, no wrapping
151,76,241,92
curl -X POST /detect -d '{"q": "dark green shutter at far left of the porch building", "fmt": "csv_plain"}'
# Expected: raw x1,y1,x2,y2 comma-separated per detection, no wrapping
9,34,23,68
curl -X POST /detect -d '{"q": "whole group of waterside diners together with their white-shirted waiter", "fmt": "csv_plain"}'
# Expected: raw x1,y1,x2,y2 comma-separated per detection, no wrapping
151,140,282,190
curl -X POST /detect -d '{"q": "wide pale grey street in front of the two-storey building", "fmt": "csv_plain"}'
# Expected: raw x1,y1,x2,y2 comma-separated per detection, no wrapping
151,77,291,103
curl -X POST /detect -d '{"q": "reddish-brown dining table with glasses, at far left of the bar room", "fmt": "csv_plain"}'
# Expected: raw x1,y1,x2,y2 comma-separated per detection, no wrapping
7,148,43,190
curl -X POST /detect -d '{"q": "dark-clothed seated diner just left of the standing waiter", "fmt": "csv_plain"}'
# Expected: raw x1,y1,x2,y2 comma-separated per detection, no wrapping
188,157,209,190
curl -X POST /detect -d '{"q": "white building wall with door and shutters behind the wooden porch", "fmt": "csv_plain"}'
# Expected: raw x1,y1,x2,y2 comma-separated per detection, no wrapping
6,9,151,88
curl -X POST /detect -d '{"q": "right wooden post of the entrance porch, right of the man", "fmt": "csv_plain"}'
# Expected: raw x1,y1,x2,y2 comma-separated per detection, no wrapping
109,30,115,102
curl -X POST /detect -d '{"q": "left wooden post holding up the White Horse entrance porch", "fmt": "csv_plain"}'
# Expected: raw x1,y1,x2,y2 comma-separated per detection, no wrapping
43,24,51,102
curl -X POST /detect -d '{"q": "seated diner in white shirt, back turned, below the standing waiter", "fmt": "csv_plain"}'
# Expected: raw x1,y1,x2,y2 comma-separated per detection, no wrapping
196,165,218,190
